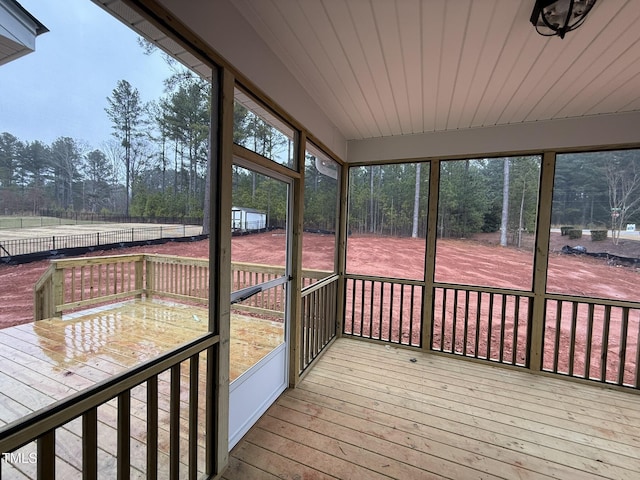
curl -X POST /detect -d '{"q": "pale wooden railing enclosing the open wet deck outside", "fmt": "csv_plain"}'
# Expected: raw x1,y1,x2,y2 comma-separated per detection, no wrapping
34,254,331,320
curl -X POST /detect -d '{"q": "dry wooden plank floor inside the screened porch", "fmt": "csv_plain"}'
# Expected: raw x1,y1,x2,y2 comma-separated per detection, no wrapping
224,339,640,480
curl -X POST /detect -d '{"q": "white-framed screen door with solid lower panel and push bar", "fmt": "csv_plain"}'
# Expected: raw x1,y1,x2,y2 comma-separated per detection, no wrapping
229,159,291,448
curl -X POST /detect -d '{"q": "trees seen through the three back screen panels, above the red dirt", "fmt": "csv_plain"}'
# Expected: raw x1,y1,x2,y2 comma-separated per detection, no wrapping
349,150,640,246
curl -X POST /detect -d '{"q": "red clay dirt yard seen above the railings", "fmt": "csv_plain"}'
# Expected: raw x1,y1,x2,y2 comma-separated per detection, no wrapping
0,232,640,328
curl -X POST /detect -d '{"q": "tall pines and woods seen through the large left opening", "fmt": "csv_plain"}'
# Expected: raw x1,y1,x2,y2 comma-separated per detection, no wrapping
0,48,211,218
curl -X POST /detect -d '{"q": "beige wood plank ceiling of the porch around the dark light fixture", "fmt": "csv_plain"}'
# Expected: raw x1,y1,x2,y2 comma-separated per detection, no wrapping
233,0,640,140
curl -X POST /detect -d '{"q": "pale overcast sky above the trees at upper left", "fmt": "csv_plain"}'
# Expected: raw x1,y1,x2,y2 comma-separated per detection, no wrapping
0,0,170,148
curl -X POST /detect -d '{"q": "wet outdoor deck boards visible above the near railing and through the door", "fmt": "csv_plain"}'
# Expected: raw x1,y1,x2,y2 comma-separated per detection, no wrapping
0,301,284,425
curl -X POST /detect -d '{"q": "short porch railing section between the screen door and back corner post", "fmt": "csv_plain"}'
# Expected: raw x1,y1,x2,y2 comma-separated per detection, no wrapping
299,275,340,373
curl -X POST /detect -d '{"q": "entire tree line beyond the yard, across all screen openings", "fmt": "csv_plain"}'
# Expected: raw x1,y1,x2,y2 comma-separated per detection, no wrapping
0,36,640,245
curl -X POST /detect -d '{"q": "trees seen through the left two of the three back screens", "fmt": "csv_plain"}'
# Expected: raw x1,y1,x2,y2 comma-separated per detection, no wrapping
349,157,540,244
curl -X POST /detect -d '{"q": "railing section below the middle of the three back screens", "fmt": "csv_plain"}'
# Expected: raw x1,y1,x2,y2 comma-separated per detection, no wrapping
431,285,533,366
